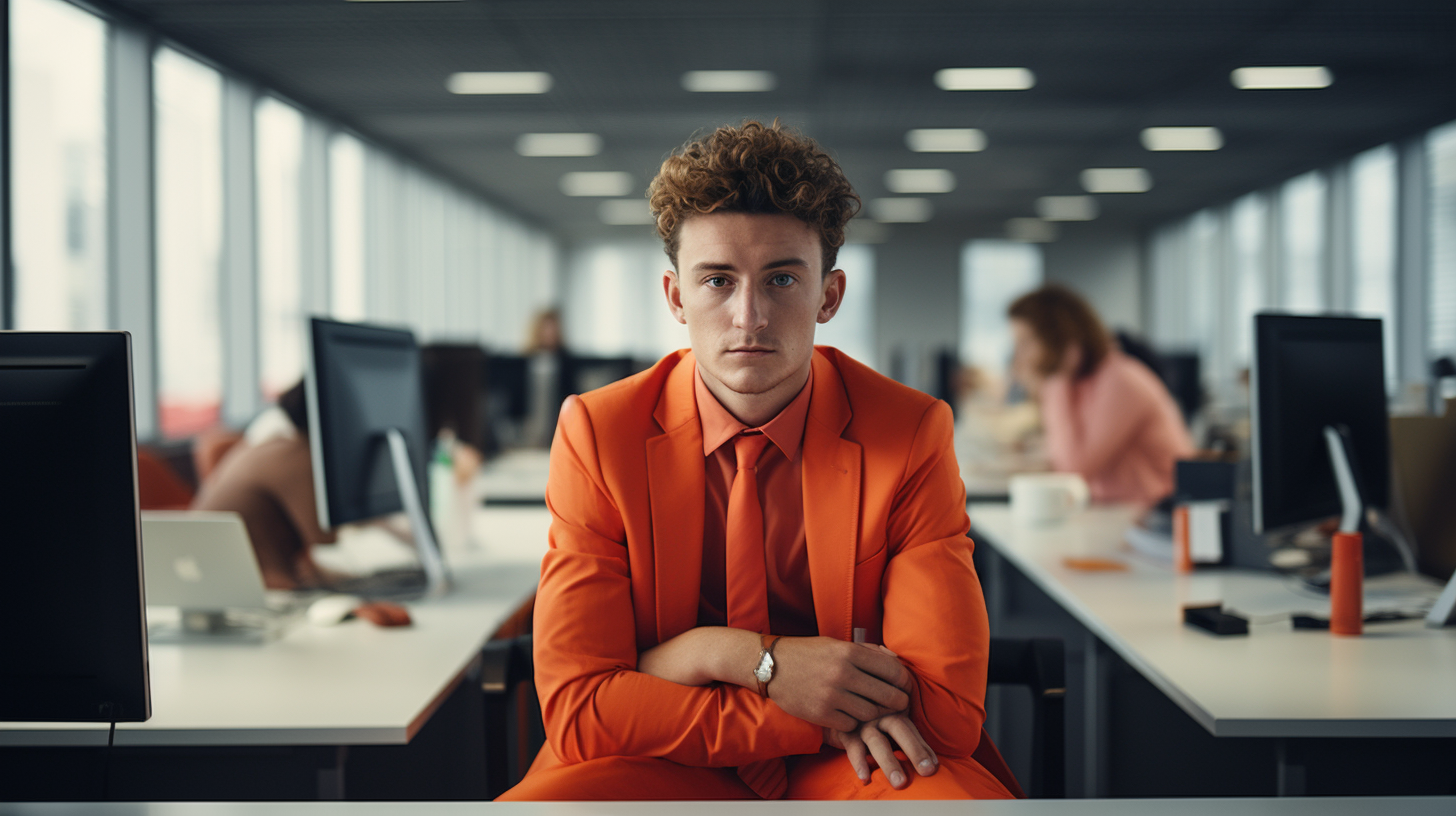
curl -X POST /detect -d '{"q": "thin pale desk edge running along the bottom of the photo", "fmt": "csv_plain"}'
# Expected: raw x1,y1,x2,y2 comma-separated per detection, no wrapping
0,797,1456,816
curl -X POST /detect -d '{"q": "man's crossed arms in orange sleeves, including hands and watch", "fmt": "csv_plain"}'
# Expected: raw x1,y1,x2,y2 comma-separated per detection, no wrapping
536,404,987,778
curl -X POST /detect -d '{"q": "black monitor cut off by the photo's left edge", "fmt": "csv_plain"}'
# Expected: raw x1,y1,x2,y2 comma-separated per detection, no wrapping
0,332,151,723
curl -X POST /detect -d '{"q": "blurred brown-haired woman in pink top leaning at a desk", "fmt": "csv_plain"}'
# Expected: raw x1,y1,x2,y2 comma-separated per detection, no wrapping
1008,284,1194,507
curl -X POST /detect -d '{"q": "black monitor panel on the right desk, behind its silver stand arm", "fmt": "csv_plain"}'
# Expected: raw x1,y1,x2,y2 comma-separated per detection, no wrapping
1251,315,1390,532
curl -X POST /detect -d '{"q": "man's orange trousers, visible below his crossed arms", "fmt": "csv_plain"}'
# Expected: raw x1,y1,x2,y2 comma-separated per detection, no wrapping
501,745,1012,801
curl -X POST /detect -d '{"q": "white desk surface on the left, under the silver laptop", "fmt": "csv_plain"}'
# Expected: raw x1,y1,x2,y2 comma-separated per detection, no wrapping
0,507,549,746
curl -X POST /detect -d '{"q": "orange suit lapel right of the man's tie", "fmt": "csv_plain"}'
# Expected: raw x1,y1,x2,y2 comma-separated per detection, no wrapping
802,353,863,640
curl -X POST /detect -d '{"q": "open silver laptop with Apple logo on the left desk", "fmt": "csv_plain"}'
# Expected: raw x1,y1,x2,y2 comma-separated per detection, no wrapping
141,510,300,638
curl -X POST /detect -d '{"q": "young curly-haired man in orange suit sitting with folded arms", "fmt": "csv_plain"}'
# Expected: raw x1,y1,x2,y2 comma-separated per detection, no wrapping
502,122,1019,800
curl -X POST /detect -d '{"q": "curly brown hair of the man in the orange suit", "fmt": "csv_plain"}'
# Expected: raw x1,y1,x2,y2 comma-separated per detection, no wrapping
646,119,860,272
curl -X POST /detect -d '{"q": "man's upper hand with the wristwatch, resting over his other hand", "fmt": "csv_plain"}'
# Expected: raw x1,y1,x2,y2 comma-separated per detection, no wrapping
769,637,914,731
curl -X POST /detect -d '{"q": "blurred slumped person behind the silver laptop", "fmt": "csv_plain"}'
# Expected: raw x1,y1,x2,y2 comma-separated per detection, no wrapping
192,380,339,589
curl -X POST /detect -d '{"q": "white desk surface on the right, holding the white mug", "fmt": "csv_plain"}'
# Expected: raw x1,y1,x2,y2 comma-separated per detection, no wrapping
970,504,1456,737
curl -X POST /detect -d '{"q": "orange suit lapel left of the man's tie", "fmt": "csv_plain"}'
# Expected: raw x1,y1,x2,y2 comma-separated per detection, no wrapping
646,354,706,643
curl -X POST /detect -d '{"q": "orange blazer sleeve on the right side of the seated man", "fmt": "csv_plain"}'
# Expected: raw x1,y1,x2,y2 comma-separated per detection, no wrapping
882,401,990,756
